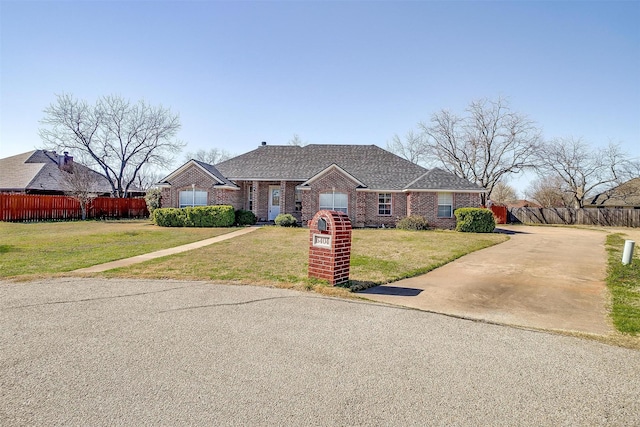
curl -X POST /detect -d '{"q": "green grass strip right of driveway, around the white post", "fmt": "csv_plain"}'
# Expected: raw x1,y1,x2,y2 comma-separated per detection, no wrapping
607,234,640,335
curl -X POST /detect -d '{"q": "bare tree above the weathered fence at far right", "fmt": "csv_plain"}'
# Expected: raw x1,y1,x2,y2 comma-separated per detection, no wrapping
537,137,630,208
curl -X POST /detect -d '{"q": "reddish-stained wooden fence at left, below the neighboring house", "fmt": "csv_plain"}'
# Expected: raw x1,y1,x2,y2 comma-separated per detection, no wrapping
0,193,149,222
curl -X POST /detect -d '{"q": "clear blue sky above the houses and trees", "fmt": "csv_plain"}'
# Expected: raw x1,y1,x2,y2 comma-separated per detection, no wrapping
0,0,640,194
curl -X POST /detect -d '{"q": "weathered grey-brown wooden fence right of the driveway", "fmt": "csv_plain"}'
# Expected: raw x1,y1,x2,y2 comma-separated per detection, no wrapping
508,208,640,227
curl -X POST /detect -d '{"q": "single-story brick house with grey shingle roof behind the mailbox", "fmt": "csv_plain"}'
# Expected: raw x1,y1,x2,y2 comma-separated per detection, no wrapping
160,143,484,228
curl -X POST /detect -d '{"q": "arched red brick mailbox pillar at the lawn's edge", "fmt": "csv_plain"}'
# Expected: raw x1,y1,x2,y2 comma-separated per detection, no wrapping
309,210,351,285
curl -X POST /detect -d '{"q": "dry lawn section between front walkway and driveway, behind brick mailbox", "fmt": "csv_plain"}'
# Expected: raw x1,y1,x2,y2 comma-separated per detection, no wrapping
102,227,508,294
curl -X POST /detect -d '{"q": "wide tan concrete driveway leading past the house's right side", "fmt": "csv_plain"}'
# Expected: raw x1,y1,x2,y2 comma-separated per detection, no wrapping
361,226,614,335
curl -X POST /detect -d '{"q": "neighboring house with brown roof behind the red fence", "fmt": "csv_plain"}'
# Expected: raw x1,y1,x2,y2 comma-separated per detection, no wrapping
0,150,111,196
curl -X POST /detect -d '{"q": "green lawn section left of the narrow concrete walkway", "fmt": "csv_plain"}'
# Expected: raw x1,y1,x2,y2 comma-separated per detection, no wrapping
0,220,232,278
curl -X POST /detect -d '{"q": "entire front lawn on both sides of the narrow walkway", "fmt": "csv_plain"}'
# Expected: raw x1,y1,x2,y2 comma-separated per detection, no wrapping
0,220,508,293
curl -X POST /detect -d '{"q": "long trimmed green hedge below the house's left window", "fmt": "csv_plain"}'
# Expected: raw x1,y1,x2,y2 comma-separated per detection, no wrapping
153,205,236,227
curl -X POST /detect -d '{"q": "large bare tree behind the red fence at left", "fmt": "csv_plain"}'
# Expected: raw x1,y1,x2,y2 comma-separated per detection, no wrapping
40,94,184,197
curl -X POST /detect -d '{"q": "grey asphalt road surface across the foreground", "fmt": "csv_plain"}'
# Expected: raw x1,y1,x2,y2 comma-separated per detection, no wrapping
0,278,640,426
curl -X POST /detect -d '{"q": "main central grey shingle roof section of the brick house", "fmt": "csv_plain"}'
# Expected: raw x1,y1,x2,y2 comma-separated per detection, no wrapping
216,144,438,190
